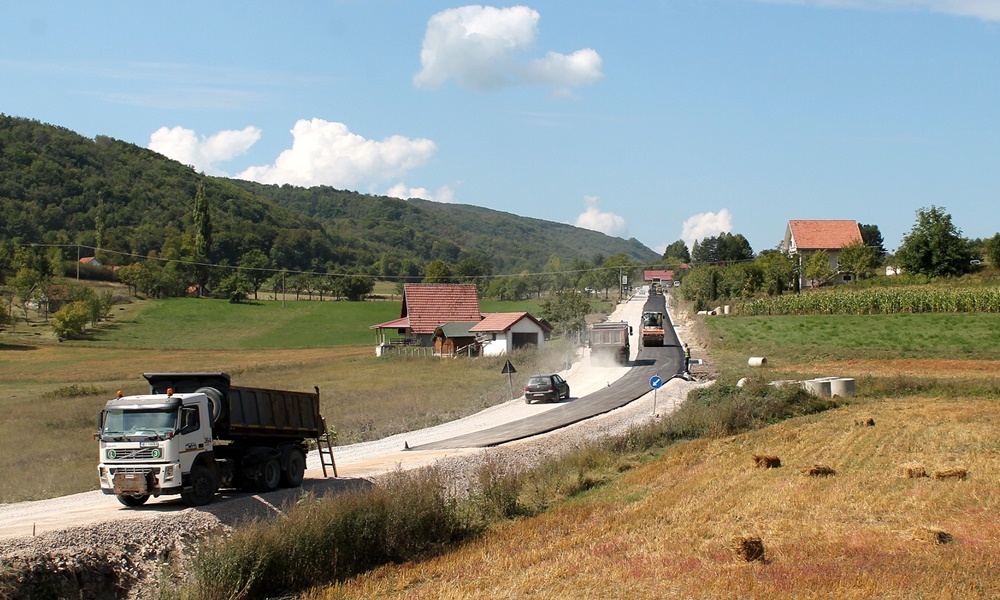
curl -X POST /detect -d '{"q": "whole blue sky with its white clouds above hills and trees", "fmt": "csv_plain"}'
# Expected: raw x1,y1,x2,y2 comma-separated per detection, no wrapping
0,0,1000,251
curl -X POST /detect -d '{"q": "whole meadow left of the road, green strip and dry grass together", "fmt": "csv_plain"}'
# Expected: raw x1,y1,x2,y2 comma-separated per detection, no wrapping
0,298,565,502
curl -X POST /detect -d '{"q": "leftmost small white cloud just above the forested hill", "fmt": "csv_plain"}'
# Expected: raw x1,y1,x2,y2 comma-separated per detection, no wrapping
149,126,261,175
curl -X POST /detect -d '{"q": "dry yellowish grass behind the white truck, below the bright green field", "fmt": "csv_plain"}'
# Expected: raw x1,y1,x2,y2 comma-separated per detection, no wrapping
0,343,561,502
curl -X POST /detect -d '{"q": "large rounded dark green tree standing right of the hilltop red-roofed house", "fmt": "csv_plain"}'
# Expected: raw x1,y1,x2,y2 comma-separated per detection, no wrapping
896,205,975,277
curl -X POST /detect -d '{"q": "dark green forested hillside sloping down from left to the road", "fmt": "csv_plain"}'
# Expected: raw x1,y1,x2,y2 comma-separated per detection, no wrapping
0,115,659,277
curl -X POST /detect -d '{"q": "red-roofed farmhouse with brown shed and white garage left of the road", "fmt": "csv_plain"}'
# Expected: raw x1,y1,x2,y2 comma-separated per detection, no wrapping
371,283,552,356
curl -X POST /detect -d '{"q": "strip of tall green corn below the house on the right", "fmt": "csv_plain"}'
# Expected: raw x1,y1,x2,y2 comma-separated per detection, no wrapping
734,287,1000,316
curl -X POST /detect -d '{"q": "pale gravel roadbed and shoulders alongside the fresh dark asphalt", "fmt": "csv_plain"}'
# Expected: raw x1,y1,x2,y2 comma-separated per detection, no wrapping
0,296,702,598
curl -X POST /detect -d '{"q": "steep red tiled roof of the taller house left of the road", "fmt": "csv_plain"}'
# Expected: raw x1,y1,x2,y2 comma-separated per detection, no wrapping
400,283,482,335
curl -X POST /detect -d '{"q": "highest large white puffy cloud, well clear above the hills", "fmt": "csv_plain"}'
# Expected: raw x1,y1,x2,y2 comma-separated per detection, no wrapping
413,6,604,91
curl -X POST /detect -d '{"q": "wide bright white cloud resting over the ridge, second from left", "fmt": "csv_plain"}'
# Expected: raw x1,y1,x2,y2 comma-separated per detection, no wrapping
237,119,437,188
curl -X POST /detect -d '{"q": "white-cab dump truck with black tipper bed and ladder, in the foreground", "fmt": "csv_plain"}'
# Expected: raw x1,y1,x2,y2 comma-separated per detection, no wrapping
94,373,326,507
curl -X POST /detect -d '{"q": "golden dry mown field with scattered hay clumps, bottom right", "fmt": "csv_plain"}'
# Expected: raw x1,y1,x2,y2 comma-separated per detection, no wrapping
311,397,1000,599
